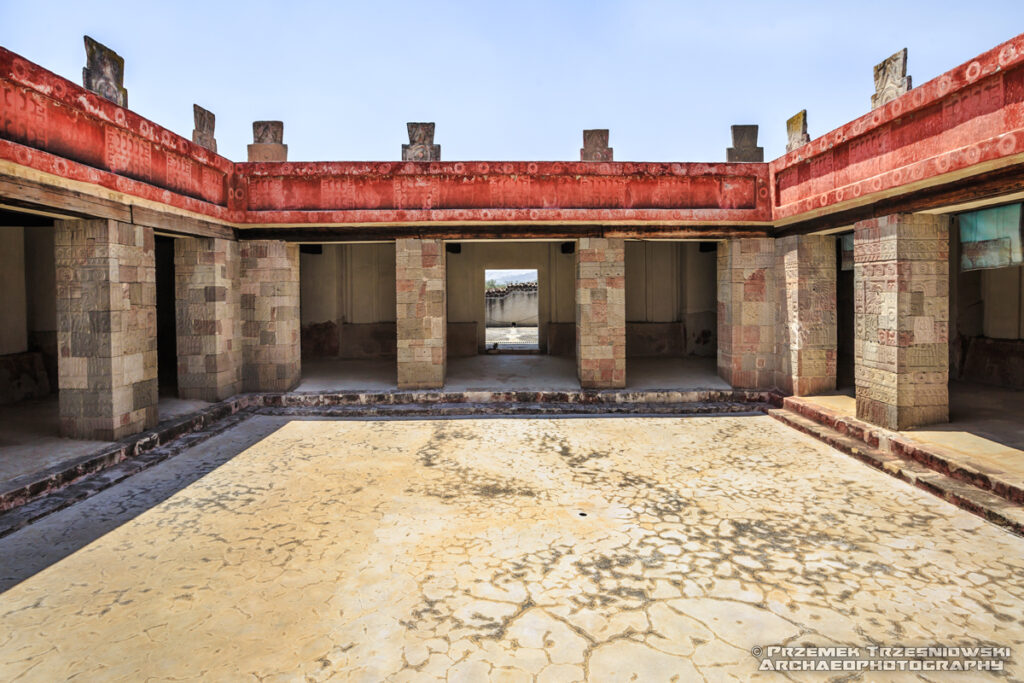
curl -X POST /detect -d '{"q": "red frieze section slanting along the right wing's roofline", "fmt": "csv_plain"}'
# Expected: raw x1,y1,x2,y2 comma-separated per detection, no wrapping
769,34,1024,222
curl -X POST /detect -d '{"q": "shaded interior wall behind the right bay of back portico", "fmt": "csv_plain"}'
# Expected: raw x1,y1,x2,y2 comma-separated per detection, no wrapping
626,241,717,356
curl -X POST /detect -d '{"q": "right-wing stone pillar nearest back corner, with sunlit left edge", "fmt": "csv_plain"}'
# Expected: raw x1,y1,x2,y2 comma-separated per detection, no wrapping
775,234,837,396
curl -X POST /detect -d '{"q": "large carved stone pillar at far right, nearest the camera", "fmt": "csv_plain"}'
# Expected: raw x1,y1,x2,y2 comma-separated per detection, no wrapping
854,214,949,429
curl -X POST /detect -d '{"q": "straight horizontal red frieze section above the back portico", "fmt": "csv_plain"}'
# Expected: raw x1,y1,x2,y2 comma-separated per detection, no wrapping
238,162,770,223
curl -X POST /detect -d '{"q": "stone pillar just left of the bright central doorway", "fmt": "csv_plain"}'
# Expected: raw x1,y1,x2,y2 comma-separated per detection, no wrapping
394,240,447,389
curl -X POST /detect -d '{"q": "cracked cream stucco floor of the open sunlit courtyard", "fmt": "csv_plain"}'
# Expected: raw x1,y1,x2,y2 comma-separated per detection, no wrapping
0,416,1024,681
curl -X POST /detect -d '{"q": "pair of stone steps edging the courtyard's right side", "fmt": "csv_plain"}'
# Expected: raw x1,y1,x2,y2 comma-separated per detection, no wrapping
768,403,1024,536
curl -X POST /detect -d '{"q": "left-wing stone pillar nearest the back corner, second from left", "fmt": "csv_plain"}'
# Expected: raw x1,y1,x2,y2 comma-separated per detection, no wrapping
174,238,242,401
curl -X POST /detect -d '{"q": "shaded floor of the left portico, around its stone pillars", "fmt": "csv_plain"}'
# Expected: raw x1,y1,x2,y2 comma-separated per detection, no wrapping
0,395,209,482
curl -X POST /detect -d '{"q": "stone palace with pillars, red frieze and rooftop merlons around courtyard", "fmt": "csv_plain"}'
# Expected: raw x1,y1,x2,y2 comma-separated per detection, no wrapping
0,36,1024,439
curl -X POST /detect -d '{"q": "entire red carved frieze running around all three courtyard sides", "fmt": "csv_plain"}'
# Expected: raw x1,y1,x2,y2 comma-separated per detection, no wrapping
0,35,1024,226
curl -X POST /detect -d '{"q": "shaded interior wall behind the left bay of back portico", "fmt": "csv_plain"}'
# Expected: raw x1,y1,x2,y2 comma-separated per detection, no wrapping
299,243,396,358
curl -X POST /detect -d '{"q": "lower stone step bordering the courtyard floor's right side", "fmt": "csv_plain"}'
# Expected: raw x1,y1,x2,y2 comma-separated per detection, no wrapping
768,408,1024,536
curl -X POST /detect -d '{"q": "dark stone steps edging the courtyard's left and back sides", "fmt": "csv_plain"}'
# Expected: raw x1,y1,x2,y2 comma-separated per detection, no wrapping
0,389,781,538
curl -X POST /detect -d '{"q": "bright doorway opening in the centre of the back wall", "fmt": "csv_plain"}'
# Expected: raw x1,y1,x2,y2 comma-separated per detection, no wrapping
483,268,541,353
